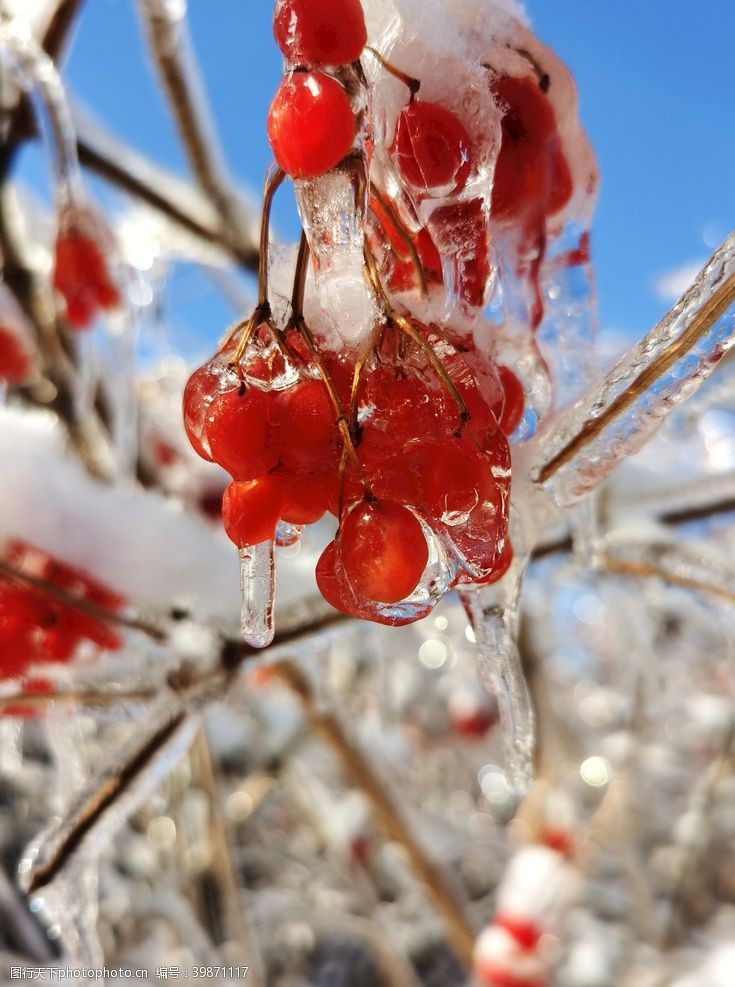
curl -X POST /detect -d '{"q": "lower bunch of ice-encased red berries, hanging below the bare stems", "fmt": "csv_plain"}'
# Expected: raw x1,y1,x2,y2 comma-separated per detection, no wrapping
184,323,523,623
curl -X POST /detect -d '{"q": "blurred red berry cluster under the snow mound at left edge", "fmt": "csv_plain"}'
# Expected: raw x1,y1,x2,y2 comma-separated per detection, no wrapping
0,543,123,679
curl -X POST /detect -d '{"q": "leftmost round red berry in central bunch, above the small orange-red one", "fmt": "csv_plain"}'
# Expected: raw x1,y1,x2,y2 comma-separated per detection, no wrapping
205,385,278,480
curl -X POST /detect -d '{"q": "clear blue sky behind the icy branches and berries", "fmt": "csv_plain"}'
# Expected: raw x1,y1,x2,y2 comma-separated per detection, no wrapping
18,0,735,350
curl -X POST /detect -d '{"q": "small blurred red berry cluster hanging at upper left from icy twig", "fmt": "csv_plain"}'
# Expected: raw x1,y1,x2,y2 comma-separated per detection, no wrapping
53,208,120,330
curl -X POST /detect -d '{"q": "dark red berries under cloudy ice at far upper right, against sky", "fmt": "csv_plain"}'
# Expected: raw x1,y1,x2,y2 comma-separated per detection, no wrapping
491,76,572,220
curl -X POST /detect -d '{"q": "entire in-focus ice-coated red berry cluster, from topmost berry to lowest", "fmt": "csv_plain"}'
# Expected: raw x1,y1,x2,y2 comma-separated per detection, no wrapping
184,0,596,624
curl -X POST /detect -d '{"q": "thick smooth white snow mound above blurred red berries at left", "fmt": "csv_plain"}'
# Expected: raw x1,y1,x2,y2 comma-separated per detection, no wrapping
0,408,315,622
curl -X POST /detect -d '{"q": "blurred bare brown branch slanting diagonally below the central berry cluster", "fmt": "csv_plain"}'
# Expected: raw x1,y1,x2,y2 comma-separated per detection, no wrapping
273,662,475,968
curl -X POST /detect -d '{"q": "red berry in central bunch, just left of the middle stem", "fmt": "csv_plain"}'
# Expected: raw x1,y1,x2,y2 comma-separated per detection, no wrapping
282,380,339,472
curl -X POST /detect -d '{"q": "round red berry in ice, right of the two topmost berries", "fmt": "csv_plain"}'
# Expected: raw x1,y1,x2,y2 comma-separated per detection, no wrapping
392,101,470,192
